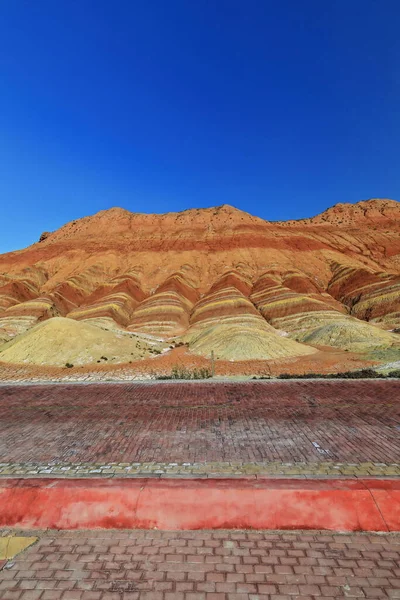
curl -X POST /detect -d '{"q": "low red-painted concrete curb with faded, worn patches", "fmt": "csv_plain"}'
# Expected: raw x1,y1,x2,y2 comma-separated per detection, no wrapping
0,477,400,531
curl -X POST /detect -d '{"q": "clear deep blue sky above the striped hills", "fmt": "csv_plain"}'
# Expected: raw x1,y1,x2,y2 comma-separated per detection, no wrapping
0,0,400,252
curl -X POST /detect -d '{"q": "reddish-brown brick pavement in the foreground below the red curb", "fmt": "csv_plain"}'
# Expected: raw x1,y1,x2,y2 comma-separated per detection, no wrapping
0,531,400,600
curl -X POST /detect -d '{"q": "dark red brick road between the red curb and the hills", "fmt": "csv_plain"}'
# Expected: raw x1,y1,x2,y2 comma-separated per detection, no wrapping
0,380,400,466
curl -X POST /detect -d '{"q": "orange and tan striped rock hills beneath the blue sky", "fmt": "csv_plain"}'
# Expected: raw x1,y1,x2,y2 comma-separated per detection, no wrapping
0,199,400,364
